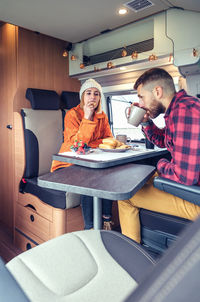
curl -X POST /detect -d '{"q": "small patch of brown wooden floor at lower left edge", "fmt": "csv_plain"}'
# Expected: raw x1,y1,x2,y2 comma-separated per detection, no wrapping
0,222,21,263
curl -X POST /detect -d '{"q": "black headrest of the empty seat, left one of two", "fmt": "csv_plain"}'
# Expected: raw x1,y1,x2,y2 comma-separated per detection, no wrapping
26,88,60,110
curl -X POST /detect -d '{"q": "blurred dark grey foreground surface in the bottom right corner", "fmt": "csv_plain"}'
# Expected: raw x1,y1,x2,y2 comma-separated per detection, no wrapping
125,218,200,302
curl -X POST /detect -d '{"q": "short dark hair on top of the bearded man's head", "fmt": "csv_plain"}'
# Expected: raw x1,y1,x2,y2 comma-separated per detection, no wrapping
134,68,174,90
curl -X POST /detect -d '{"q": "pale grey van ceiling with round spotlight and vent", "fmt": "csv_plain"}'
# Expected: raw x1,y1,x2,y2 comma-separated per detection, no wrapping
0,0,200,43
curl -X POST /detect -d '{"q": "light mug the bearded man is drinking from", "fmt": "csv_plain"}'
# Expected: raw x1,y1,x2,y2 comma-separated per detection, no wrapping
125,105,146,127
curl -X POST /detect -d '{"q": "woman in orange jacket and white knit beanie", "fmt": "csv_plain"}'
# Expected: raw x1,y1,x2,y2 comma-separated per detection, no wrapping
51,79,113,229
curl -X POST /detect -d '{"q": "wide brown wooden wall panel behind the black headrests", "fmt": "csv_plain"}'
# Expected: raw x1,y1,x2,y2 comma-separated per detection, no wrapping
14,28,80,111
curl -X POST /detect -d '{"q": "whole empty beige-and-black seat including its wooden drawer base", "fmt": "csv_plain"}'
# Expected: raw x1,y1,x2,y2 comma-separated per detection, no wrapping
14,88,83,250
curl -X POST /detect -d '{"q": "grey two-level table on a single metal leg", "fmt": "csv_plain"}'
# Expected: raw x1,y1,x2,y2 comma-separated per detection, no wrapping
38,145,159,229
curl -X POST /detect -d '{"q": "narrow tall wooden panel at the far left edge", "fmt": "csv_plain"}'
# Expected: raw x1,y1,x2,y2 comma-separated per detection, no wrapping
0,24,18,227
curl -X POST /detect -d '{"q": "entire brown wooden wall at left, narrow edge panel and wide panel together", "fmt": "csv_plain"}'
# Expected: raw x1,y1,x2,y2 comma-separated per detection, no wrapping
0,24,80,234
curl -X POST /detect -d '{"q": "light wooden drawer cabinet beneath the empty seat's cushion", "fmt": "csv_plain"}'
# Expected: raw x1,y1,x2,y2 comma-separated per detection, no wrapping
14,193,84,251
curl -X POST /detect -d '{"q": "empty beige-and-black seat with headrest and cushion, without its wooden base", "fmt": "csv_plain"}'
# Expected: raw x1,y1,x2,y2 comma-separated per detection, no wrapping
20,88,80,209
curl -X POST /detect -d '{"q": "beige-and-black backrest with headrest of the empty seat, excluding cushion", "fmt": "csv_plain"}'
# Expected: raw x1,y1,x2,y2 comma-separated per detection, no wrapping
21,88,63,178
